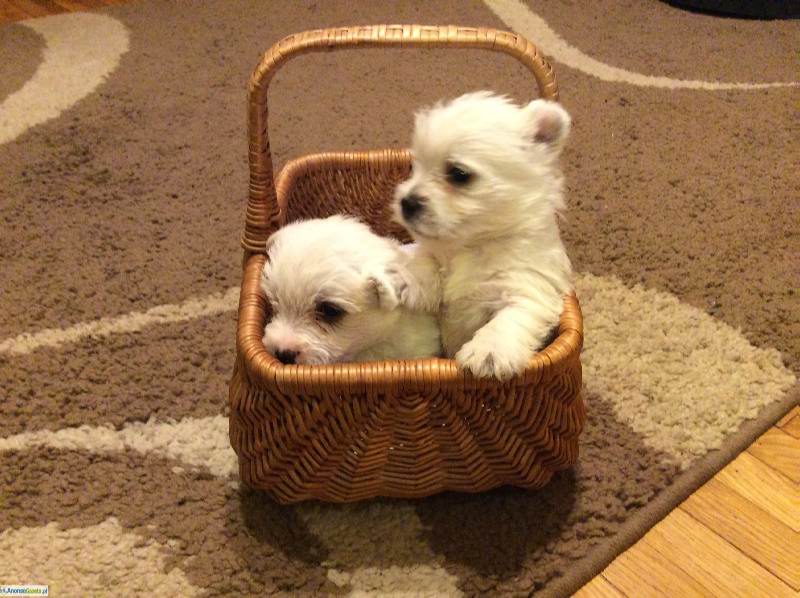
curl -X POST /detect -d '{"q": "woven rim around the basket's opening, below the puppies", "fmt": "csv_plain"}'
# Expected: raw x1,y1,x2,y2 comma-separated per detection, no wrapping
237,149,583,390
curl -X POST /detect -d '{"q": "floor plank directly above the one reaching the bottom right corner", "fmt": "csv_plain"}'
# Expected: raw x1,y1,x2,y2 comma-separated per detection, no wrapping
680,479,800,590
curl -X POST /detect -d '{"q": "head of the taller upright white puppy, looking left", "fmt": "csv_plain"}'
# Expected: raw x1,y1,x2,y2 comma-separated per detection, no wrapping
394,92,570,242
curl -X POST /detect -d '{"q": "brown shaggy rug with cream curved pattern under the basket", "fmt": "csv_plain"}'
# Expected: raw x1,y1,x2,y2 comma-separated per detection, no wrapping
0,0,800,596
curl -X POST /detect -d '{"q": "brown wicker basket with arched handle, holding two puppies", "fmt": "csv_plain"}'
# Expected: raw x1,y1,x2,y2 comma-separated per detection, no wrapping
230,25,585,503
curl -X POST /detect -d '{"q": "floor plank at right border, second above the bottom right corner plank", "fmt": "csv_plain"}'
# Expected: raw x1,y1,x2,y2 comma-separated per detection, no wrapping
715,452,800,532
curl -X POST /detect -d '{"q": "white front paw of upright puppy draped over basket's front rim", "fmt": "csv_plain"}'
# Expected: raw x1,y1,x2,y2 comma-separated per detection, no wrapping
455,304,553,380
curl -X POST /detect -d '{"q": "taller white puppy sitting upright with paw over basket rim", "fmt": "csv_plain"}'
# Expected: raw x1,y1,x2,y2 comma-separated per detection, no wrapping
395,92,572,379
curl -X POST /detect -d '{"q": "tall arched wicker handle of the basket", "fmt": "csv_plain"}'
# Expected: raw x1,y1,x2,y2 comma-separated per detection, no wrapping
242,25,558,253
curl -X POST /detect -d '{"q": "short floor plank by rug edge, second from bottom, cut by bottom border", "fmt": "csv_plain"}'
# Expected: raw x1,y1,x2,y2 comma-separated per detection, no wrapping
603,540,711,598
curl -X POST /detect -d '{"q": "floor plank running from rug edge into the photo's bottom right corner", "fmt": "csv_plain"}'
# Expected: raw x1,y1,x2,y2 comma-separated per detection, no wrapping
644,509,796,598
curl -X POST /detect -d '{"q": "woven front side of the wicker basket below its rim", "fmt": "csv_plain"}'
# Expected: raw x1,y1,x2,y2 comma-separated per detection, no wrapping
230,357,585,503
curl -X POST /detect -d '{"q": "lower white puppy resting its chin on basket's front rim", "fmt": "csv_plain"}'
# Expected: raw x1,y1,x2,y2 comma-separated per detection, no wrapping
261,216,441,364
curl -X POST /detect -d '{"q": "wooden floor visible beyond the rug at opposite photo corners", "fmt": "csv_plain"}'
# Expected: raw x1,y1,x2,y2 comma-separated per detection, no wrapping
0,0,800,598
